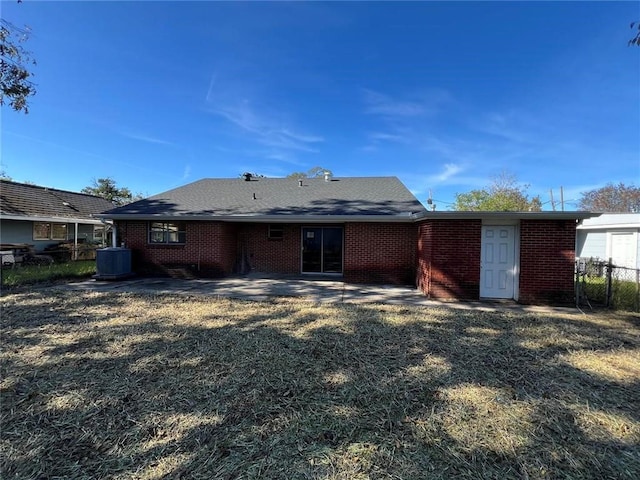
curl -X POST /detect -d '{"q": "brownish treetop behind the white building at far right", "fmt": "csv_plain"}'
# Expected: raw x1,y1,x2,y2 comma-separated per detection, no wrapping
578,182,640,213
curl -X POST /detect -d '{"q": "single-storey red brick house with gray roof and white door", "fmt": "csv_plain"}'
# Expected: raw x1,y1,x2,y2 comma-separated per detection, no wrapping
98,176,589,303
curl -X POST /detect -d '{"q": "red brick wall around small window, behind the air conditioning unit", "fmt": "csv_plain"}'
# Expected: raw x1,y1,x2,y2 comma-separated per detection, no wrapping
117,221,236,277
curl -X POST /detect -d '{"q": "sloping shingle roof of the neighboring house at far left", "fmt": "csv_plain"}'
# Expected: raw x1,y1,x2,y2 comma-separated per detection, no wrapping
0,180,113,219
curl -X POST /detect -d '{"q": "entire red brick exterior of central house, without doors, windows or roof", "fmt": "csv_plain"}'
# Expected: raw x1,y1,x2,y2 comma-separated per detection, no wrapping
117,220,576,304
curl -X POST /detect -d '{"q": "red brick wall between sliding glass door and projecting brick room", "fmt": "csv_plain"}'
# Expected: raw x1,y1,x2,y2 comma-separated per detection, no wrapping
344,223,416,285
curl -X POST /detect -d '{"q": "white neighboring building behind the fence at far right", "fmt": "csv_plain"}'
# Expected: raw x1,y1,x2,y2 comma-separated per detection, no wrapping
576,213,640,269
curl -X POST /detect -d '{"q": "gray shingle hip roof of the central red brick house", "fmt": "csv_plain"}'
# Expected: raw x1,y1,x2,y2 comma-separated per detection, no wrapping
105,177,425,218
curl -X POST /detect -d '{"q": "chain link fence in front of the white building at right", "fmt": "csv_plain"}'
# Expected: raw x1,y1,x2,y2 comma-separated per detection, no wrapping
576,258,640,312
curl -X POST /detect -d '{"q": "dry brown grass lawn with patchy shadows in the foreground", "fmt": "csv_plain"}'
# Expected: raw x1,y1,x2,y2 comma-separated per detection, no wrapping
0,291,640,479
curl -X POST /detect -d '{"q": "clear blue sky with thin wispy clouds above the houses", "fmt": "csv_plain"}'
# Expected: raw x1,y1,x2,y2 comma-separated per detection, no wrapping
0,0,640,210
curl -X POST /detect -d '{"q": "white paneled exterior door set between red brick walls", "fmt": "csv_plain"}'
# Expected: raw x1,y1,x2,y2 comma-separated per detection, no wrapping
480,225,516,298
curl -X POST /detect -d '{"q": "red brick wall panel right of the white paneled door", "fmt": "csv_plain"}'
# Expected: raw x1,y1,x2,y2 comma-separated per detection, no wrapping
518,220,576,304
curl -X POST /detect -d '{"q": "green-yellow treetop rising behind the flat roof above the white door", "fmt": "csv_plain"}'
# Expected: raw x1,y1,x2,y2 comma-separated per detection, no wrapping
452,173,542,212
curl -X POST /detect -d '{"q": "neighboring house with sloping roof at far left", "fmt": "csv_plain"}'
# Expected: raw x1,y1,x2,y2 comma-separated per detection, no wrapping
0,180,113,252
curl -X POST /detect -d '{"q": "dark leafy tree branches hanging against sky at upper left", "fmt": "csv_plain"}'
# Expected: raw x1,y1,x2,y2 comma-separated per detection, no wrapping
0,18,36,113
